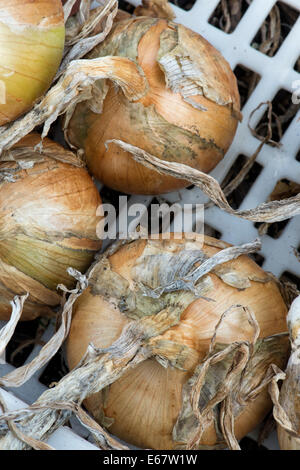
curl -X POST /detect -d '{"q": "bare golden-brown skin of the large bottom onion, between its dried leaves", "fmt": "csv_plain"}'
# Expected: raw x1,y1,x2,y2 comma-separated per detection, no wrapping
66,237,288,449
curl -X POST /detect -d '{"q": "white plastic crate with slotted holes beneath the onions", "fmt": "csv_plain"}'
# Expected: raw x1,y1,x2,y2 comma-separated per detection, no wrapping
0,0,300,449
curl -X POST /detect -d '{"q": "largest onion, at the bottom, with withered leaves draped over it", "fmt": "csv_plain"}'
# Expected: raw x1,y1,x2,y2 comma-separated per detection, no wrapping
67,237,288,449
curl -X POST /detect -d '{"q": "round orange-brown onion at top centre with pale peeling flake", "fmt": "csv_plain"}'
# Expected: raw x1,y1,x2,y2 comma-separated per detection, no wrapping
65,17,240,194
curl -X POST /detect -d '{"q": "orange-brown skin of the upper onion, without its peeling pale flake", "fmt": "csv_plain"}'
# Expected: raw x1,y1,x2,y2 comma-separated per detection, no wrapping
66,17,240,195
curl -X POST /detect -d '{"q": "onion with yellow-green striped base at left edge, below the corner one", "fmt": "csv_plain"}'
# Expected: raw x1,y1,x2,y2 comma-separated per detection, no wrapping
0,134,101,320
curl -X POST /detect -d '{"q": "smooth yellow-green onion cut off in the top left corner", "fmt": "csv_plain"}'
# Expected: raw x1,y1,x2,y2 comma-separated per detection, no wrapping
0,0,65,126
